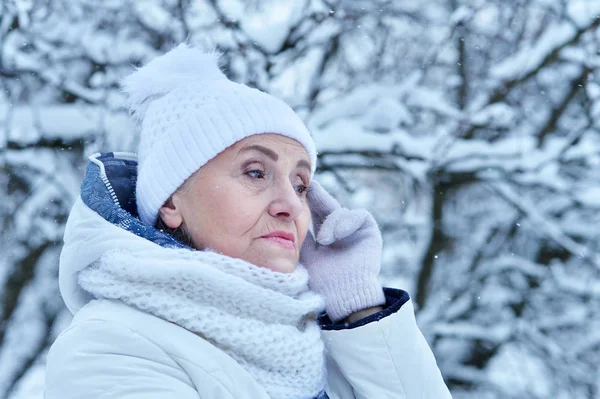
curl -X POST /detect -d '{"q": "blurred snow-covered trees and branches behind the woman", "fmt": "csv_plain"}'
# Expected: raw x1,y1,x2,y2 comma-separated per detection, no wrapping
0,0,600,399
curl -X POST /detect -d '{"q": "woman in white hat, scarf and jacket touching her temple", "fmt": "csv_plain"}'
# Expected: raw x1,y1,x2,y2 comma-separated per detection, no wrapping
45,45,450,399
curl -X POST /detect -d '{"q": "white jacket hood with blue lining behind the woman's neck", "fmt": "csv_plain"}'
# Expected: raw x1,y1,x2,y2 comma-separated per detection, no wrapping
58,152,191,314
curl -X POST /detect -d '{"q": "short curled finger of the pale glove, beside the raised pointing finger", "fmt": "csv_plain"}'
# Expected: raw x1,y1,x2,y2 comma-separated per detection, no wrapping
317,208,372,245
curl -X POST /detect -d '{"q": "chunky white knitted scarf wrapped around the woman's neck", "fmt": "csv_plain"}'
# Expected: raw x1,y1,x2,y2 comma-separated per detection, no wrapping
79,247,326,399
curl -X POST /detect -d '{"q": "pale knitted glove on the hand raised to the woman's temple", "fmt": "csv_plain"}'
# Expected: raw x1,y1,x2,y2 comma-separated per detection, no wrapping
300,180,385,322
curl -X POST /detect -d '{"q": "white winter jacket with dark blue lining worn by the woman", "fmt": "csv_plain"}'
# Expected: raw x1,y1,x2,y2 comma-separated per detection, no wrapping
45,154,450,399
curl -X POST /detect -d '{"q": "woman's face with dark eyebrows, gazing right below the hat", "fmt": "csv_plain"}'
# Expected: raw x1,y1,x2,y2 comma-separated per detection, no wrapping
159,134,311,273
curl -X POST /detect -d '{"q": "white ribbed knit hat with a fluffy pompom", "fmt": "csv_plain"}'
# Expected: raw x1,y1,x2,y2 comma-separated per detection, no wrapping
123,44,317,225
